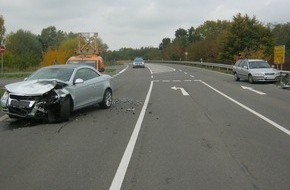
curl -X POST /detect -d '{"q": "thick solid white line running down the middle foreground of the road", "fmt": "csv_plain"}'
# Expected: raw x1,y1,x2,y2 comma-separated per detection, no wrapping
110,81,153,190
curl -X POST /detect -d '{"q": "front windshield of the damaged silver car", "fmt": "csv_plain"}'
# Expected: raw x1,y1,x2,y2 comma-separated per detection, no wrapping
27,68,74,82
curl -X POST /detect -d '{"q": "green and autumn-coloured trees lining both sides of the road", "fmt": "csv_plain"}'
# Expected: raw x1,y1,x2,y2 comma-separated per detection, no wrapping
0,13,290,71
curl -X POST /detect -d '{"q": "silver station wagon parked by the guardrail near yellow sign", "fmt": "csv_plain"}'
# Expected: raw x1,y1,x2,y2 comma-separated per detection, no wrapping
233,59,280,83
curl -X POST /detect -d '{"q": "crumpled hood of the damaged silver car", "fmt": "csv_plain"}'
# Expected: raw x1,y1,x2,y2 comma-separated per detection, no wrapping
5,80,67,95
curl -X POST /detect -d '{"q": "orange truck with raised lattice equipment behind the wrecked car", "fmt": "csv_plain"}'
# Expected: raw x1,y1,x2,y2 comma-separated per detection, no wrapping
66,32,105,72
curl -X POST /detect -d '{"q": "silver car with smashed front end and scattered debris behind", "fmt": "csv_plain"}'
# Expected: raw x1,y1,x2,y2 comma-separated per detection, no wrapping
1,65,112,122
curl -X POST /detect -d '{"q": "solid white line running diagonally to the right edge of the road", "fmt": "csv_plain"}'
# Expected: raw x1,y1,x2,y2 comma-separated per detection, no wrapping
199,80,290,135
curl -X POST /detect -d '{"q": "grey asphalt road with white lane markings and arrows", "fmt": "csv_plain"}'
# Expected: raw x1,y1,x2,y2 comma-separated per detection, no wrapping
0,63,290,190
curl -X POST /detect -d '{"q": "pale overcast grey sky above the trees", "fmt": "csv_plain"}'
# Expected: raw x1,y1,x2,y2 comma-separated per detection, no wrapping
0,0,290,50
